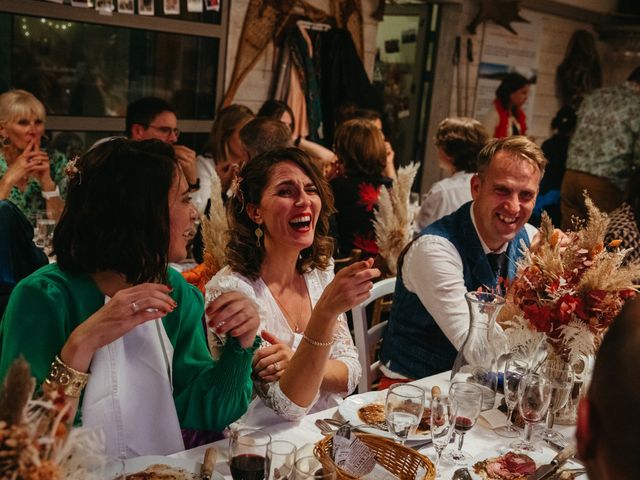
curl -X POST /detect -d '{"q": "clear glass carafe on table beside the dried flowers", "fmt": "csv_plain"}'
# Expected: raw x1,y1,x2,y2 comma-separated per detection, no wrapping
451,292,505,410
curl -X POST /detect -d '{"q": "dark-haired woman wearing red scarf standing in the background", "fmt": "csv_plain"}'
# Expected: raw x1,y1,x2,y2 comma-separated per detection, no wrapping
482,72,531,138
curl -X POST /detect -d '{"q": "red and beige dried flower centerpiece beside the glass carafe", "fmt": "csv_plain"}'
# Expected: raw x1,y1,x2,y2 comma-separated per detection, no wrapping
506,196,640,364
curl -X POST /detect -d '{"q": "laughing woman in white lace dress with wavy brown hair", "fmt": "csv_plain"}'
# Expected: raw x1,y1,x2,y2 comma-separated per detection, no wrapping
206,148,380,425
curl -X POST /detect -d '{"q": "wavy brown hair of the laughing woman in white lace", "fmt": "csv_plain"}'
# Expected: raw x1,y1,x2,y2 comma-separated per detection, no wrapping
226,148,335,280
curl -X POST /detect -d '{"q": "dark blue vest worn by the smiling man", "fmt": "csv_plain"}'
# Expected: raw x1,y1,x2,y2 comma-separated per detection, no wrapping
380,202,529,379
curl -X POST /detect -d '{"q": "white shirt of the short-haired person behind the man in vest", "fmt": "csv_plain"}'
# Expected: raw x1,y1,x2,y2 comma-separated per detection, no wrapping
416,171,474,232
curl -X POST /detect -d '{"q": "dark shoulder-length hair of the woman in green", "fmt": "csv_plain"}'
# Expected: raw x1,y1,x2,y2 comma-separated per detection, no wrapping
53,138,180,284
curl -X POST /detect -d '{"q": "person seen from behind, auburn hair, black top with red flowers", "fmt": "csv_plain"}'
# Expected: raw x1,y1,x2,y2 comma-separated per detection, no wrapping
331,120,393,258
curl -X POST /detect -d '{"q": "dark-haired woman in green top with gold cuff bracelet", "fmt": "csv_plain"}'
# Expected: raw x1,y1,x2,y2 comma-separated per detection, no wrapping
0,138,260,457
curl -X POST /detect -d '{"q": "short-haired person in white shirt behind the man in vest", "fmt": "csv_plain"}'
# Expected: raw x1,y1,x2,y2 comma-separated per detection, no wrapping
416,117,488,232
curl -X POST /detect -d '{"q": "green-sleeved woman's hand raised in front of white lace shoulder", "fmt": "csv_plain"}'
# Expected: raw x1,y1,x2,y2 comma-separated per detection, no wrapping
205,292,260,348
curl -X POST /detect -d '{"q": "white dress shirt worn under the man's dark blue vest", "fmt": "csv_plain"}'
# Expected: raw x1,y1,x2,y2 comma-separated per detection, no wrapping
382,206,538,378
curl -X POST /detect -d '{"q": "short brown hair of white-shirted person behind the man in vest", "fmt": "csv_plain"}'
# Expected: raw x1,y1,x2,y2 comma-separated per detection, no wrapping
434,117,489,173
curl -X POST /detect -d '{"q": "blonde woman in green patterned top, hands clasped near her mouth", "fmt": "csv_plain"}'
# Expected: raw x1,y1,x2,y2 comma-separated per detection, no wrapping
0,90,67,225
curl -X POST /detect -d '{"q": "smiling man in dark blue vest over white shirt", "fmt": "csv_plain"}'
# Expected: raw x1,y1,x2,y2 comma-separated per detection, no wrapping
381,136,547,386
